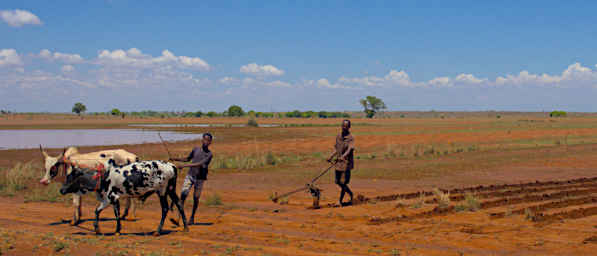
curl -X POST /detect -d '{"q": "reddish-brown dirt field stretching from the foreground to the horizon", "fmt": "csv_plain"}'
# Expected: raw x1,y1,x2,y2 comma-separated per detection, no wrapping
0,116,597,255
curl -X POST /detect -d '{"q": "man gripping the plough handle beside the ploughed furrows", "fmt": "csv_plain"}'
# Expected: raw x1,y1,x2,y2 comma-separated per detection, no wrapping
327,120,354,206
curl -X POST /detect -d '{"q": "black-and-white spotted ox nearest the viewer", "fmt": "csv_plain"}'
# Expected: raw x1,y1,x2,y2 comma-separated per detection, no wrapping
60,159,188,235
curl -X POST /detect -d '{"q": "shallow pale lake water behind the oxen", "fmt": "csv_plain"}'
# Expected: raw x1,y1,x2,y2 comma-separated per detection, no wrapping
0,129,201,150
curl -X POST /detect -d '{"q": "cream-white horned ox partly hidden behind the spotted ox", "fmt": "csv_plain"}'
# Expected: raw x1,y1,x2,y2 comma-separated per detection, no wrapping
39,145,139,225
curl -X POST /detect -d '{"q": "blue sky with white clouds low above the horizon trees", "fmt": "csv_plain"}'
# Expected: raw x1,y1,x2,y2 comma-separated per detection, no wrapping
0,0,597,112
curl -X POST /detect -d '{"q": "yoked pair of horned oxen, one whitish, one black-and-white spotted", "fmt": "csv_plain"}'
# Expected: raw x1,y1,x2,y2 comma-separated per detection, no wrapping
40,145,188,235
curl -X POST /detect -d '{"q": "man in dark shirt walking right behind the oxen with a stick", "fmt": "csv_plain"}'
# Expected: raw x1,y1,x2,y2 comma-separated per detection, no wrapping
170,133,213,225
